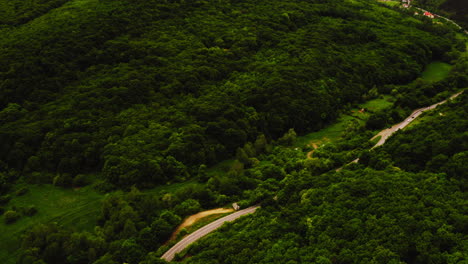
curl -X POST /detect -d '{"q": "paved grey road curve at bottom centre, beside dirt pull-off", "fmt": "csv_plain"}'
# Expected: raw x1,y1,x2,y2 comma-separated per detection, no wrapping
161,206,260,261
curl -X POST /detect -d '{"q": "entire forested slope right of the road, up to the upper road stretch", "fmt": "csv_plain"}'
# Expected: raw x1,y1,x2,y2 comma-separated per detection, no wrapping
177,94,468,264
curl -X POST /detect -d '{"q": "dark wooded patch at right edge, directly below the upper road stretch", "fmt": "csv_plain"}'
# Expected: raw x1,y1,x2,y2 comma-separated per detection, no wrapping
369,93,468,177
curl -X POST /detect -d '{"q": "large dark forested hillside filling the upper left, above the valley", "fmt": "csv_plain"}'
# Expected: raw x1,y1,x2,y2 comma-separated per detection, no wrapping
0,0,460,188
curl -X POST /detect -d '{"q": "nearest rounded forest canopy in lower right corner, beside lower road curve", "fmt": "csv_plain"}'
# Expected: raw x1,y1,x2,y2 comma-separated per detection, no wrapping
184,170,466,263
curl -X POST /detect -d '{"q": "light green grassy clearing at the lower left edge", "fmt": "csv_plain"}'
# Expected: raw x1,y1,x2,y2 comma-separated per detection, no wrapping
0,185,104,264
